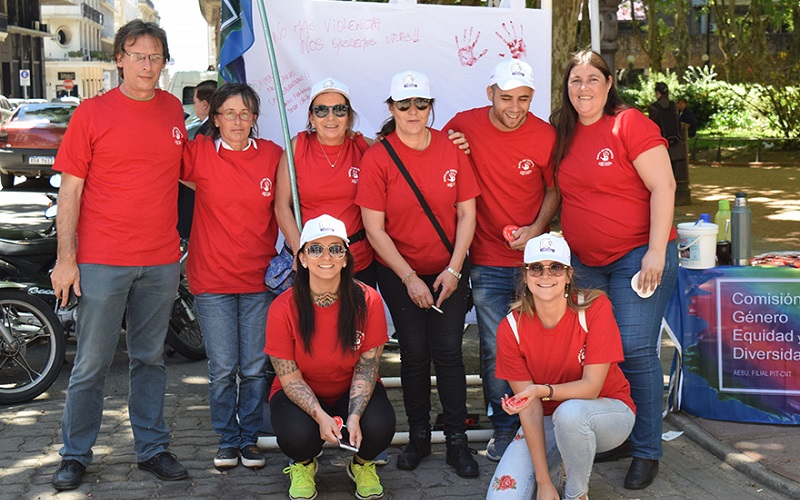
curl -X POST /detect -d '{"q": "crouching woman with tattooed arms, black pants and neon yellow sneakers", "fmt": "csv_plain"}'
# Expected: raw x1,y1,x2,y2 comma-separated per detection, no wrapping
265,215,395,499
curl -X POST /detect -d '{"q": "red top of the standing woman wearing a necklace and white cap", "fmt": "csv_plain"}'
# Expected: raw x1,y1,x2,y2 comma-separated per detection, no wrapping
294,132,374,271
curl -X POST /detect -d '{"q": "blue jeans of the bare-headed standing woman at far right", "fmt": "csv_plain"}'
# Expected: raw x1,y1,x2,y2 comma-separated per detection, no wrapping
572,241,678,460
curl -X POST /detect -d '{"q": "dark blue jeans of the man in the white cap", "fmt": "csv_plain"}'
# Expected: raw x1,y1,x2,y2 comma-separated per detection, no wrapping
470,266,520,431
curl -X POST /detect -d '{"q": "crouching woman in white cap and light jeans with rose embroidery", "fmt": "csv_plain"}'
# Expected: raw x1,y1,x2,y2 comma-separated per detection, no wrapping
487,233,636,500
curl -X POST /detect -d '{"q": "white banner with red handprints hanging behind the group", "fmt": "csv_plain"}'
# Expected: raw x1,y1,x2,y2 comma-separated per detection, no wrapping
245,0,551,145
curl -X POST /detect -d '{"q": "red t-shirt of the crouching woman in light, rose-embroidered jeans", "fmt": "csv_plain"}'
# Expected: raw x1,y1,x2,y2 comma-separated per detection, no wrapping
497,296,636,415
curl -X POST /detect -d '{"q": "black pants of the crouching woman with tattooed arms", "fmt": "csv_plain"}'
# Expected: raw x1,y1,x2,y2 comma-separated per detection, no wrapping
269,384,395,462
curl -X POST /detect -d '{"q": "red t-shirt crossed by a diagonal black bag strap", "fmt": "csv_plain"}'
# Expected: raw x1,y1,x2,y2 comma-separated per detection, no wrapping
356,129,480,275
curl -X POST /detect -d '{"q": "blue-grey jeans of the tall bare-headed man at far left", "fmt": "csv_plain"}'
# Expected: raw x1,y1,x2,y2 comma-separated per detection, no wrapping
60,263,180,465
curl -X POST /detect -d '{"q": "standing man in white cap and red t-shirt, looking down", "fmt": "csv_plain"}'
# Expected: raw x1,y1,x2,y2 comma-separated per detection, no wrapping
444,59,559,461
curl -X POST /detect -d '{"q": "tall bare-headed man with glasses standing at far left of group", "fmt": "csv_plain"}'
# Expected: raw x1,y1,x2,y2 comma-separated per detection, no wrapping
51,20,188,490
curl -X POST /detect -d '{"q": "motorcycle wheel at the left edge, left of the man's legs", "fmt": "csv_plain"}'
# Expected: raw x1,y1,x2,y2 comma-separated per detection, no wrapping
0,289,66,404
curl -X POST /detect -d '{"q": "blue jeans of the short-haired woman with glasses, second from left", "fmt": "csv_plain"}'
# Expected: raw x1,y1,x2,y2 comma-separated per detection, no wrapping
194,291,275,448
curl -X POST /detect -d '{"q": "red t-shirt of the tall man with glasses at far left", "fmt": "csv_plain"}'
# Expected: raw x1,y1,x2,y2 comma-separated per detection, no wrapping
53,88,186,266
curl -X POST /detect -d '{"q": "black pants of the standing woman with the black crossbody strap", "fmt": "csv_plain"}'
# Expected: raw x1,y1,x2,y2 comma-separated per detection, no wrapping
377,262,469,435
